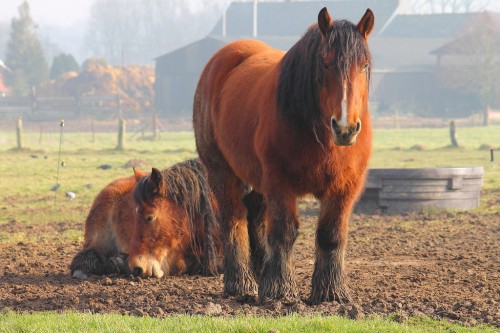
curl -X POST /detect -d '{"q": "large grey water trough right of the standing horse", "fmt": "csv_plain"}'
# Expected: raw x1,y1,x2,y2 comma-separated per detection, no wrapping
355,167,484,213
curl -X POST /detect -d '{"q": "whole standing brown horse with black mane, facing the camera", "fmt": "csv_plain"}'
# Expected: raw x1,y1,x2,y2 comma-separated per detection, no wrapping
193,8,374,304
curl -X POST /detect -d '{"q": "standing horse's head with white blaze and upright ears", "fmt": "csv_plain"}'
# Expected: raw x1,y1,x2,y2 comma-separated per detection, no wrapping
318,8,375,146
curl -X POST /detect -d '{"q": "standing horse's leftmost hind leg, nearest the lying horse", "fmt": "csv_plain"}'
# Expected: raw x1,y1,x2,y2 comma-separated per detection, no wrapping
205,163,257,297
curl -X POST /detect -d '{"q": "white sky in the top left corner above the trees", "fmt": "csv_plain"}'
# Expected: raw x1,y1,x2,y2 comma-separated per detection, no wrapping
0,0,94,26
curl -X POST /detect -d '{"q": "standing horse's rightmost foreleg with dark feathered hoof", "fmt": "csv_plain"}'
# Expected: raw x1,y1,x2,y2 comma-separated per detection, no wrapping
309,198,353,304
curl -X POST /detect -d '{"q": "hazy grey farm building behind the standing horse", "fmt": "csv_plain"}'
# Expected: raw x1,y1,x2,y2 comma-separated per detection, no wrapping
155,0,497,117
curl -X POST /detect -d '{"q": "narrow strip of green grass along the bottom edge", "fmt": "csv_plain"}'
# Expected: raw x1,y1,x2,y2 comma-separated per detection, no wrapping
0,312,494,333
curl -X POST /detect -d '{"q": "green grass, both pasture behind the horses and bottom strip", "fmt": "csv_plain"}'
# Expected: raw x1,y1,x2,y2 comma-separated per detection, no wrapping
0,126,500,332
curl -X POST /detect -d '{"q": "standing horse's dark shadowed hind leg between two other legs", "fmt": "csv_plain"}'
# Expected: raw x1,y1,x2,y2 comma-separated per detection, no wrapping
243,191,266,277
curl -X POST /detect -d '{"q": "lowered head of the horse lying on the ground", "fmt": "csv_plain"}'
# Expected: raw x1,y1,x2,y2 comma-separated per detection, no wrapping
129,168,182,278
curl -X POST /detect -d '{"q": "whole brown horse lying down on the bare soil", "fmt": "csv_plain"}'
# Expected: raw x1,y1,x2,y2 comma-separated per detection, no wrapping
70,160,221,278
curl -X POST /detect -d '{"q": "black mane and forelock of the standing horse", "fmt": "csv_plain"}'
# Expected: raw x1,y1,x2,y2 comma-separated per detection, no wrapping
276,20,371,131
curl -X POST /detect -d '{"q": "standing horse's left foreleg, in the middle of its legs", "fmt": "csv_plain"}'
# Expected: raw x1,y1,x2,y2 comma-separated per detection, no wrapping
259,198,299,303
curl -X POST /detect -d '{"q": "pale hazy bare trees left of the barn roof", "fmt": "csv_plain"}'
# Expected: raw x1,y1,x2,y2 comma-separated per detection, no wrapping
87,0,226,64
